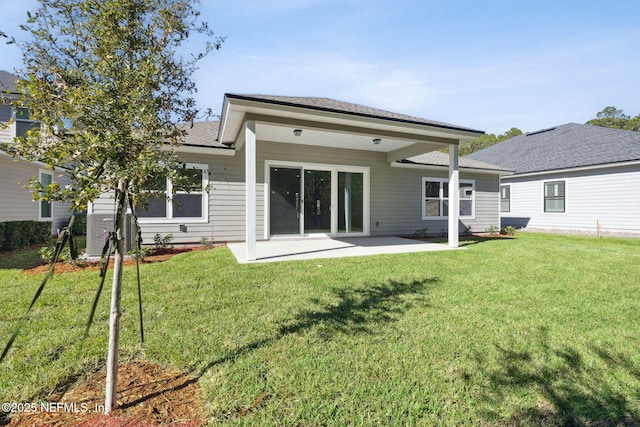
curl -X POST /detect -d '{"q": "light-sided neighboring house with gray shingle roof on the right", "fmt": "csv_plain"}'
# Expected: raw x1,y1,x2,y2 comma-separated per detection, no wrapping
468,123,640,235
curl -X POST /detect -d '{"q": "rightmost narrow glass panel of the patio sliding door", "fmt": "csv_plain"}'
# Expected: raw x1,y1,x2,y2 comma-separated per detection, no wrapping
338,172,364,233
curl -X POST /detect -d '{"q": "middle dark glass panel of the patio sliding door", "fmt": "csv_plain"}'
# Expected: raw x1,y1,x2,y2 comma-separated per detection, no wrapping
304,170,331,234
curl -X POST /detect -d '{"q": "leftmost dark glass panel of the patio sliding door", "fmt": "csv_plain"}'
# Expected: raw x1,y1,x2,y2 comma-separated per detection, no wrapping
269,167,301,235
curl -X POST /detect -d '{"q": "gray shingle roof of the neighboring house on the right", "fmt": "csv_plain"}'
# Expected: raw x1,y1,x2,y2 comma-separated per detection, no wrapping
467,123,640,174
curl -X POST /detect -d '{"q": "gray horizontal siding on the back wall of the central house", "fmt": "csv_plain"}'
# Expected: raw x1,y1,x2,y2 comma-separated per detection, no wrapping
93,141,499,244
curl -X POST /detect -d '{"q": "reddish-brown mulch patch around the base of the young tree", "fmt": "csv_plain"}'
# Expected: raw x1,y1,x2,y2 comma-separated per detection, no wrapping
9,361,207,427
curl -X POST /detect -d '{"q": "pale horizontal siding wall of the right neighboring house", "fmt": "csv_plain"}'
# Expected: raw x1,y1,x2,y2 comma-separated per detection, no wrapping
502,165,640,234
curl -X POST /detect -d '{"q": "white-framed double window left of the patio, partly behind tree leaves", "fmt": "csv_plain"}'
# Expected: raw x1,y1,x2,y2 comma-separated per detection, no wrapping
136,163,209,222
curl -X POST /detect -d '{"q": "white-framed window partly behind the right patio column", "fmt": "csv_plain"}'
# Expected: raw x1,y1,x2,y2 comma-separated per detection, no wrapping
422,178,475,219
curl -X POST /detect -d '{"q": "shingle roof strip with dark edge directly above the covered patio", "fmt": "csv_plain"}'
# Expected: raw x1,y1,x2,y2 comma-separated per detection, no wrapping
225,93,484,134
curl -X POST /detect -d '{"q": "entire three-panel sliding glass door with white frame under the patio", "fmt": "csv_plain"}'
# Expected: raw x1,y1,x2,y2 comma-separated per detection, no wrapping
269,166,365,236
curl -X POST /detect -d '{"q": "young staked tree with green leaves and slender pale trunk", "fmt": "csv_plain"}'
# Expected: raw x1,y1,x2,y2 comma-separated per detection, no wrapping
10,0,223,413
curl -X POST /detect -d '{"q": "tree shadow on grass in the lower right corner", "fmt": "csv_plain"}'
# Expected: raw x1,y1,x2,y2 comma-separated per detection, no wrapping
476,328,640,426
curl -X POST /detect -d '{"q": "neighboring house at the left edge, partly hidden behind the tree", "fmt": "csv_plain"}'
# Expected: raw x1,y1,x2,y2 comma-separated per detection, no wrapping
0,71,71,234
